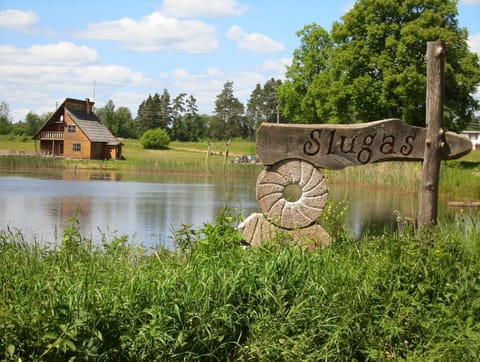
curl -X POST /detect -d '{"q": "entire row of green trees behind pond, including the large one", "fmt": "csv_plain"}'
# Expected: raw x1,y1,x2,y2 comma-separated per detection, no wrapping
0,0,480,141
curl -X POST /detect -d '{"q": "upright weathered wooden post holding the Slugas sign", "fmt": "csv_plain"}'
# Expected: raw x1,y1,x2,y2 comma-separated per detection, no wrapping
418,42,445,228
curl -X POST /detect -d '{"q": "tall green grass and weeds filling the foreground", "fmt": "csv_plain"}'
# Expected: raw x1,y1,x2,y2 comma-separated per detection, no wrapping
0,214,480,361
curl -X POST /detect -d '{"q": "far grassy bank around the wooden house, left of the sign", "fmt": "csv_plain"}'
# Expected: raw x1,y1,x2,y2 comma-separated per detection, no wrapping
0,136,262,175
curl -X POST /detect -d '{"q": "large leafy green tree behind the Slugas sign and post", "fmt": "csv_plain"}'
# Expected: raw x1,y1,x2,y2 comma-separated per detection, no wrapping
279,0,480,131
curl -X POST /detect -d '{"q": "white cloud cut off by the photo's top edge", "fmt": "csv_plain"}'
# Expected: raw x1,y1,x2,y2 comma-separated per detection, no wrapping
162,0,247,18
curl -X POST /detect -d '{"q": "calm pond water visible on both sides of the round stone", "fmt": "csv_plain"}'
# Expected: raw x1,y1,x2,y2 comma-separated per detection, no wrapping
0,171,432,248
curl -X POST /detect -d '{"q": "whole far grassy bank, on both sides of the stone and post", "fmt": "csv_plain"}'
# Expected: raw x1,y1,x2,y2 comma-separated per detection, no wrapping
0,136,480,201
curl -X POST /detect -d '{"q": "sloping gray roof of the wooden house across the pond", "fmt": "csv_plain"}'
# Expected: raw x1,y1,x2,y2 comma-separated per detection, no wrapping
65,108,120,145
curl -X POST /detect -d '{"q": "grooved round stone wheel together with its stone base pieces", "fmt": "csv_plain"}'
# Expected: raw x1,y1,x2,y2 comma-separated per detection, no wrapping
239,160,330,249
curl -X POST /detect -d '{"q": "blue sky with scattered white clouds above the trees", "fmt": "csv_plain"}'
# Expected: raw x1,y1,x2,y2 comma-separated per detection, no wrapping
0,0,480,122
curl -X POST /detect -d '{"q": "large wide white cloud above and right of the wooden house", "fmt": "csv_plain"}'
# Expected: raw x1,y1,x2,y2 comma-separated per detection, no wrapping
79,12,218,53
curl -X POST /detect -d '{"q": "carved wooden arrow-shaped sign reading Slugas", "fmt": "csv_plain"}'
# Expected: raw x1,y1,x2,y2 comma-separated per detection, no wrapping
257,119,472,170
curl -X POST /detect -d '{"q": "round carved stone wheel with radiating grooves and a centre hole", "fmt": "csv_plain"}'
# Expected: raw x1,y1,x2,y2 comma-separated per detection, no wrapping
257,160,328,229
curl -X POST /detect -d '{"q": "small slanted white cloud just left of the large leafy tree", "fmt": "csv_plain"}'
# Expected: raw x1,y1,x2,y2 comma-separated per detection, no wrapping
227,25,284,53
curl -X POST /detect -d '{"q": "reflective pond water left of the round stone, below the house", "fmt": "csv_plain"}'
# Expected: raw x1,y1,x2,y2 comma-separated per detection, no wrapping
0,171,257,247
